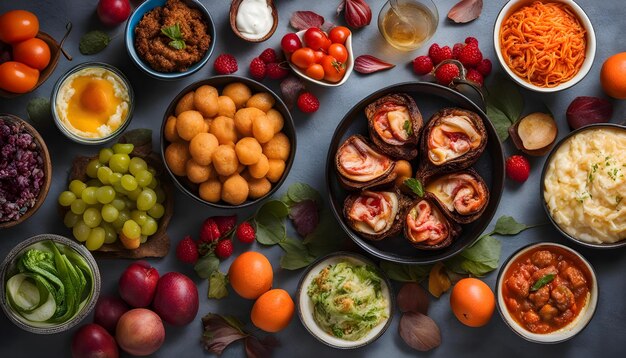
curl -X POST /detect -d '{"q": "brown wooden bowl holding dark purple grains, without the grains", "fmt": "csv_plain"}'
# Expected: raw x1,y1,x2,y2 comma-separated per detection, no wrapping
0,114,52,229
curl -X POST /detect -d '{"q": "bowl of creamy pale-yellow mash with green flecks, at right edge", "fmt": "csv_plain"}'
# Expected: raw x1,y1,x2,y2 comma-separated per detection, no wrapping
541,124,626,248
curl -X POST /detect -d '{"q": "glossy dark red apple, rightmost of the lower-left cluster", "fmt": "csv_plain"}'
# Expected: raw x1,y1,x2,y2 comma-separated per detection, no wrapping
153,272,198,326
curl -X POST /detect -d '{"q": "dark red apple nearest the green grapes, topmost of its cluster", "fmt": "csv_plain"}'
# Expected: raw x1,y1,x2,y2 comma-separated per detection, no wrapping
118,260,159,307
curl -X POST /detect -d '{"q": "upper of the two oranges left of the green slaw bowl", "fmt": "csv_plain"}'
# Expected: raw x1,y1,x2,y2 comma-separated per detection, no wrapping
228,251,274,300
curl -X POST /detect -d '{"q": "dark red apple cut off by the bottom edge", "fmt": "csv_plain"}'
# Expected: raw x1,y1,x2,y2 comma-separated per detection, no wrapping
72,323,119,358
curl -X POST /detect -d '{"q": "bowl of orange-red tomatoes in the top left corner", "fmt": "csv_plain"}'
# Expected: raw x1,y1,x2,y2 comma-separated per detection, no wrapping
0,10,71,98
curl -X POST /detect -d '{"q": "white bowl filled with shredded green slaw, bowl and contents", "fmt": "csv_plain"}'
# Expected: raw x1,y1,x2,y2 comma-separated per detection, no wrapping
296,252,394,349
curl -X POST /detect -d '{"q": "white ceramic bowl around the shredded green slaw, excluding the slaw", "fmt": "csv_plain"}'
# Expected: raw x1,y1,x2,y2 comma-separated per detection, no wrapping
296,252,395,349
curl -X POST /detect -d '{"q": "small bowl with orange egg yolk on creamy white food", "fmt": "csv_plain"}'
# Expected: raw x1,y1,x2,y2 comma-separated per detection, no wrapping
51,62,134,144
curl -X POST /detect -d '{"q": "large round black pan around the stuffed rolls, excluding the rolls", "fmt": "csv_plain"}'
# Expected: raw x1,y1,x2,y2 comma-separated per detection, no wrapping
326,82,504,264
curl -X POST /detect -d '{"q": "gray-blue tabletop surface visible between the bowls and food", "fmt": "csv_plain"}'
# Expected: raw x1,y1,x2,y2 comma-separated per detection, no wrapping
0,0,626,357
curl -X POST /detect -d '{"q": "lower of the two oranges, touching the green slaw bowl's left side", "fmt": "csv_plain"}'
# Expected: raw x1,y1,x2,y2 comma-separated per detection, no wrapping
250,288,295,333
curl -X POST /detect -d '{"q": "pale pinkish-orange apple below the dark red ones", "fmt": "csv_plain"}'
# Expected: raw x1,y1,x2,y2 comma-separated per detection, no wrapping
115,308,165,356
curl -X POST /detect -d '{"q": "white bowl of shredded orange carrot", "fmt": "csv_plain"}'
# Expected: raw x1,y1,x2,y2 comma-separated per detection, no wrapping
493,0,596,92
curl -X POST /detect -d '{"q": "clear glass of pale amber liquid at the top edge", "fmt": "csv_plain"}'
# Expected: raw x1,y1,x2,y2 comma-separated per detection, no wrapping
378,0,439,51
